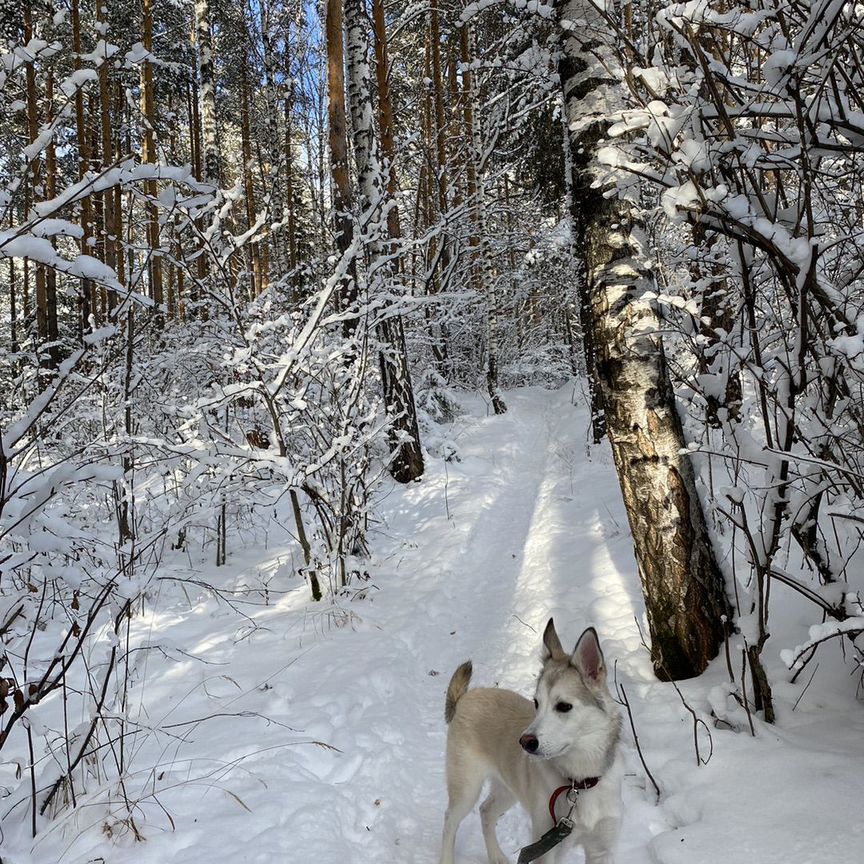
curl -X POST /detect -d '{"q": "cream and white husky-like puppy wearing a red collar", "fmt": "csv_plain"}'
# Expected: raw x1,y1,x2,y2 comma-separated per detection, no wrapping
441,618,622,864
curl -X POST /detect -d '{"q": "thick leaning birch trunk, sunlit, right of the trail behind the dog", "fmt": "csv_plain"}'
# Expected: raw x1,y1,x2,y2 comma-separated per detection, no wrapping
557,0,730,679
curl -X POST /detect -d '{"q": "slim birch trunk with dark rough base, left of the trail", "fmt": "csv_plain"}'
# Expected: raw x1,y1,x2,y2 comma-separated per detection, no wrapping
345,0,424,483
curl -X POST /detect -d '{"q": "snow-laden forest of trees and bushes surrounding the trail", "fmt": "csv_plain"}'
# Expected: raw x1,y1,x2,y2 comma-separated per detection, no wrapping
0,0,864,860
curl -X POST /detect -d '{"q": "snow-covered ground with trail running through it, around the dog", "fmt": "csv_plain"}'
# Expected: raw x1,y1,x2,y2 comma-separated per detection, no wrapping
11,388,864,864
